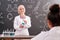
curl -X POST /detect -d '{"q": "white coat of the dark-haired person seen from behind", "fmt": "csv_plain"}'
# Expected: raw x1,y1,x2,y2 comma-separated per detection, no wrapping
31,26,60,40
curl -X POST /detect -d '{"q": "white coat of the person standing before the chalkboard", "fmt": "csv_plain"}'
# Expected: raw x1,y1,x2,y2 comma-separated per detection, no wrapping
14,15,31,35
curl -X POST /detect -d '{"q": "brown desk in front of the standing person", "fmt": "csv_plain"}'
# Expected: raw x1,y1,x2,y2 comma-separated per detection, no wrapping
0,35,34,40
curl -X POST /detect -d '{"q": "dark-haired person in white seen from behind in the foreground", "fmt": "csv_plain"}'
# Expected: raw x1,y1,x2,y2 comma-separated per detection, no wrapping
31,4,60,40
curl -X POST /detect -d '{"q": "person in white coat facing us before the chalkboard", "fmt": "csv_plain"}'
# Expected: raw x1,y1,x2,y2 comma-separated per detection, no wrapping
14,5,31,35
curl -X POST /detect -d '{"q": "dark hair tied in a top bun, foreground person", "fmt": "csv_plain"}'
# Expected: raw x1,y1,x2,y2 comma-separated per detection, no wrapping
47,4,60,26
